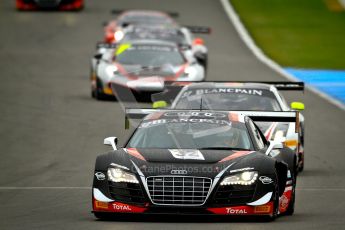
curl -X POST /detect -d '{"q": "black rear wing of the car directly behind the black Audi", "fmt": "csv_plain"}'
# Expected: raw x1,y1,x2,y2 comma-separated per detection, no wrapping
151,81,304,102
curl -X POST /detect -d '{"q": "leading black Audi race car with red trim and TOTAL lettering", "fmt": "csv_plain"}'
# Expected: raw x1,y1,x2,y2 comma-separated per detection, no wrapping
92,109,298,220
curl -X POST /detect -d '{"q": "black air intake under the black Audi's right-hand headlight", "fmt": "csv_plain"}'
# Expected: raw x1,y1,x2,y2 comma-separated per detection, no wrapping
213,184,255,205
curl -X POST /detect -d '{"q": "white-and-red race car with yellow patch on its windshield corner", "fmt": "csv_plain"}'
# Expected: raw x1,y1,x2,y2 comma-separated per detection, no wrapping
91,40,205,99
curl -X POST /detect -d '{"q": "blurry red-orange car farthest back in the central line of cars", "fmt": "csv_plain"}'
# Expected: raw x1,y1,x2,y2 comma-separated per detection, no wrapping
104,10,177,43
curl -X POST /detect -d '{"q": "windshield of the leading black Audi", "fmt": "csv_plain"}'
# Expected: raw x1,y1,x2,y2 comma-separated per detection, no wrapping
127,119,252,150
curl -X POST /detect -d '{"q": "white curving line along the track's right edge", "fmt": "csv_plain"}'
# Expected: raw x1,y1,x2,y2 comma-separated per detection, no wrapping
220,0,345,110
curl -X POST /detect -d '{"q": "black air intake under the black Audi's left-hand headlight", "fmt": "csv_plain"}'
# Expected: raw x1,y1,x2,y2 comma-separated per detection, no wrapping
109,181,147,204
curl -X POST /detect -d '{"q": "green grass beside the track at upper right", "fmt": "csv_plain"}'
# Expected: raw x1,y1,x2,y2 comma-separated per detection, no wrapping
231,0,345,69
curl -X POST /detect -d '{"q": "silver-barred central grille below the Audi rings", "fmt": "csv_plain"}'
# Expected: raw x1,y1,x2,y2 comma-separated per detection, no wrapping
146,176,212,206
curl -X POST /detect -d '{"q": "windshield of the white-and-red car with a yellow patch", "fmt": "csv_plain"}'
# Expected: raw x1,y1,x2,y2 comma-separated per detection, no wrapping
115,46,185,67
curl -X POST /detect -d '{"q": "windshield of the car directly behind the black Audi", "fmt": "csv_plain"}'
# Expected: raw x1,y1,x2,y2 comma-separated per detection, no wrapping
175,88,281,111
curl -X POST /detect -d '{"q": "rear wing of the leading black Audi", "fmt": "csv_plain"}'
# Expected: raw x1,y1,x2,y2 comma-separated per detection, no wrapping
125,108,299,133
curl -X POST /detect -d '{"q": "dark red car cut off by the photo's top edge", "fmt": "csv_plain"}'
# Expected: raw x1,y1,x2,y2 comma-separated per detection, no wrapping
16,0,84,10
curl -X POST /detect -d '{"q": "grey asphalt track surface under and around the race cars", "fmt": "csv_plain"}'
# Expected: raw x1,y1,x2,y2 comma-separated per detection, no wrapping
0,0,345,230
